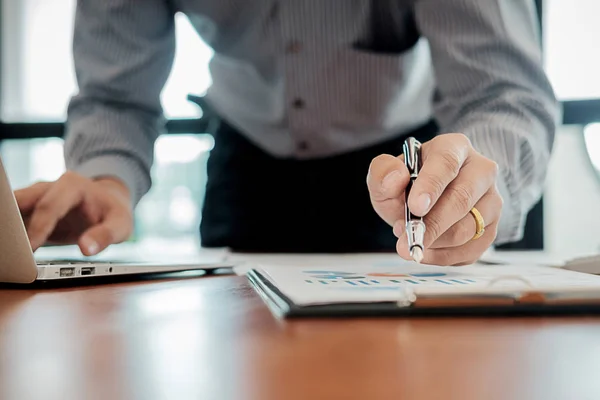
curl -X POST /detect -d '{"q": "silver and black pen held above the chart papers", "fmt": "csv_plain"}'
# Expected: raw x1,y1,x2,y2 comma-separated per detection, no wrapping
402,137,425,263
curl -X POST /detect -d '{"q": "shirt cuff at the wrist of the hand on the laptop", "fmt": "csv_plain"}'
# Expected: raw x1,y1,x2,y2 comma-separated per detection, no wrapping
69,154,152,207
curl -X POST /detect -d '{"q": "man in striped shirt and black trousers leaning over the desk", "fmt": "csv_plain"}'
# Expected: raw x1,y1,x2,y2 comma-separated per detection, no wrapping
16,0,558,265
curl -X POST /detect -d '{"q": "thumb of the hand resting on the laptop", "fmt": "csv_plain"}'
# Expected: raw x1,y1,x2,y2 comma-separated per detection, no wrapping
78,212,132,256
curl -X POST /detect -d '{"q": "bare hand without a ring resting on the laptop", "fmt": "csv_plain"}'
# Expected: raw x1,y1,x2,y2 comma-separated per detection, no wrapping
15,172,133,256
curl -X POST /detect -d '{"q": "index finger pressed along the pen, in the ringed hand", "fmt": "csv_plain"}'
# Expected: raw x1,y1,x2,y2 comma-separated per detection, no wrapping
408,137,469,217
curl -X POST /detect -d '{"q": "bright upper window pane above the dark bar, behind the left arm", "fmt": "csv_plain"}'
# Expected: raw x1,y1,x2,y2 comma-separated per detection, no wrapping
1,0,212,122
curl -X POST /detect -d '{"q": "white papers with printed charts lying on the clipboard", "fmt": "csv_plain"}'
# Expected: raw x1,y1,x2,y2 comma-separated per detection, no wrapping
256,260,600,305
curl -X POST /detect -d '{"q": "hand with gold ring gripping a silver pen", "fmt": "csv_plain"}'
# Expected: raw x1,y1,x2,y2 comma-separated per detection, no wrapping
367,134,502,265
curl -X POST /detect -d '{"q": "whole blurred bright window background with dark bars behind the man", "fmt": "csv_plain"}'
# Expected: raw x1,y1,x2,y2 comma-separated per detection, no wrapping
0,0,600,252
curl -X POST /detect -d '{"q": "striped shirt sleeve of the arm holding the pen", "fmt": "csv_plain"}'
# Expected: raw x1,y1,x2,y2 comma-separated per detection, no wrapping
415,0,561,244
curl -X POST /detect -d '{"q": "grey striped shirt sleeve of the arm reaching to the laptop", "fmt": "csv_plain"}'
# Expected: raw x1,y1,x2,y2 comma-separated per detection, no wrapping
65,0,175,206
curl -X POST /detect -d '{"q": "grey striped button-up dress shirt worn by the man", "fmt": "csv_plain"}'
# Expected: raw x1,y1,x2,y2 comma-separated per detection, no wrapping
65,0,560,244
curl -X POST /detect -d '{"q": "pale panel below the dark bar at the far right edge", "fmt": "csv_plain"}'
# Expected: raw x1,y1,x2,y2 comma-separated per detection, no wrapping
544,126,600,254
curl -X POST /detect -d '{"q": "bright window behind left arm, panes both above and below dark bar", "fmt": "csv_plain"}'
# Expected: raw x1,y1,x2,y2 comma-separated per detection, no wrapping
0,0,213,240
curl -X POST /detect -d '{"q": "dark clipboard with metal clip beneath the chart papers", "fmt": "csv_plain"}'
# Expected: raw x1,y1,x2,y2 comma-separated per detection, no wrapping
247,266,600,318
